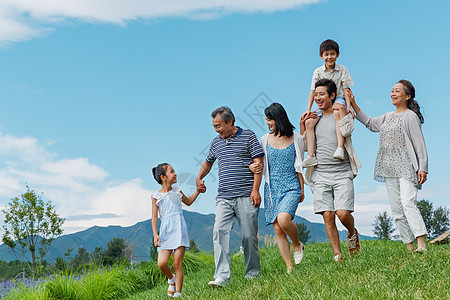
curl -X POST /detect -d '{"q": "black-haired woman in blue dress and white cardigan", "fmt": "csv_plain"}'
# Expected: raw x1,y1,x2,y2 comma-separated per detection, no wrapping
250,103,305,273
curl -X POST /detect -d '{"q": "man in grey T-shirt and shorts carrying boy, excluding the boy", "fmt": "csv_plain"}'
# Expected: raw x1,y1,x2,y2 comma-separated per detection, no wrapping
300,79,361,262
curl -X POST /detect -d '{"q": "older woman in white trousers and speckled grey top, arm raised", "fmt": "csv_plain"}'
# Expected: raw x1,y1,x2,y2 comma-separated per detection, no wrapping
347,80,428,252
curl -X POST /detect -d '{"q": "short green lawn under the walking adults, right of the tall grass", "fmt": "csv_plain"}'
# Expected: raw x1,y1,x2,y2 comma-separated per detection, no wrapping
126,241,450,300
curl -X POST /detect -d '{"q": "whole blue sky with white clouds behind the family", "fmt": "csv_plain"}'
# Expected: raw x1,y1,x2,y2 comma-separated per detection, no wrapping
0,0,450,239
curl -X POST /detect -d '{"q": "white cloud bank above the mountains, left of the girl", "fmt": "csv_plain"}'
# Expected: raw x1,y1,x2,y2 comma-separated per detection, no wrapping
0,133,155,233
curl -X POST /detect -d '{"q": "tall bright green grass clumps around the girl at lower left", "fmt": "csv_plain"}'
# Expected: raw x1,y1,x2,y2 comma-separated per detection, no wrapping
2,253,213,300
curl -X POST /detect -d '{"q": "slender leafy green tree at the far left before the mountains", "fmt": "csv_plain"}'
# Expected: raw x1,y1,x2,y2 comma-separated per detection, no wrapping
2,186,65,277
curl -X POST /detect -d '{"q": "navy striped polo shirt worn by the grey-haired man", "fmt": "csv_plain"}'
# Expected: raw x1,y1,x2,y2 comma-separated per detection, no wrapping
206,127,264,199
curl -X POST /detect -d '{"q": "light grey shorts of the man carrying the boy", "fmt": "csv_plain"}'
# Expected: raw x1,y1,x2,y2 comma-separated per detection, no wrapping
312,171,354,214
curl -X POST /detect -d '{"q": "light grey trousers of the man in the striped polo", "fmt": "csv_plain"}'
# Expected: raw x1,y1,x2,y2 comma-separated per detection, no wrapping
213,197,261,280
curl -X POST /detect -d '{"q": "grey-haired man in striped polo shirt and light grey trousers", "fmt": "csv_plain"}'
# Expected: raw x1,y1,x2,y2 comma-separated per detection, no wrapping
196,106,264,287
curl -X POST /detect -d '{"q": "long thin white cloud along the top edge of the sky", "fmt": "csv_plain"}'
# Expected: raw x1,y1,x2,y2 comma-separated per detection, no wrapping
0,0,321,42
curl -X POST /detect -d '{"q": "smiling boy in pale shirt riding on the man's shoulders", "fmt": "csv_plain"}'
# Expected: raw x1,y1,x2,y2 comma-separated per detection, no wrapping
303,40,354,168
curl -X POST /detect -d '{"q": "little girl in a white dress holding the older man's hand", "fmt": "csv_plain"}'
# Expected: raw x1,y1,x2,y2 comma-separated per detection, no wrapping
152,163,199,298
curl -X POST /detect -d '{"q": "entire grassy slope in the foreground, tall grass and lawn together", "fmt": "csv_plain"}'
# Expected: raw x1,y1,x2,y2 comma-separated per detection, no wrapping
0,241,450,300
